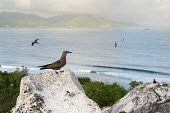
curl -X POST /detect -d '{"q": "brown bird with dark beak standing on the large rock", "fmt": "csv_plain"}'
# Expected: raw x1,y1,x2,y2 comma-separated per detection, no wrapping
38,51,72,73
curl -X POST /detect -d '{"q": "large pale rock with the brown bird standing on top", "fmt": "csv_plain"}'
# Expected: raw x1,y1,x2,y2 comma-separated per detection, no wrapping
11,70,101,113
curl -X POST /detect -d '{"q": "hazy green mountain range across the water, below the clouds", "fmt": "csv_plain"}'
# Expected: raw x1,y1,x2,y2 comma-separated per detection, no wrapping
0,12,135,28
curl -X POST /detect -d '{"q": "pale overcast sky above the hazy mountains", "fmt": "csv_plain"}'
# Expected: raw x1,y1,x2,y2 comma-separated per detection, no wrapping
0,0,170,26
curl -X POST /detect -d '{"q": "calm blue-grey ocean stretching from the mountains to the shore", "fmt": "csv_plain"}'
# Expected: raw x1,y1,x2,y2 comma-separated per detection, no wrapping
0,27,170,88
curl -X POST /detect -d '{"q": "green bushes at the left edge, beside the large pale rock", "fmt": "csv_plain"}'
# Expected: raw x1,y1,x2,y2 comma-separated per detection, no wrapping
0,66,28,113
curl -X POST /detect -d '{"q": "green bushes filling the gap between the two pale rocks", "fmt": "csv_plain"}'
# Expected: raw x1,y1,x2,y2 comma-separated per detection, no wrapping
78,77,127,107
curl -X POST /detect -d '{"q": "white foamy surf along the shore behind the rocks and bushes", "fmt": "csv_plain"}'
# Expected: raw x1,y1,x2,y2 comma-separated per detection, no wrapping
0,65,170,89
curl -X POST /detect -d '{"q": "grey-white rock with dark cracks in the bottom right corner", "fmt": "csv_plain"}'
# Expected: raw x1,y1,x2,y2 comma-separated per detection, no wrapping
110,83,170,113
